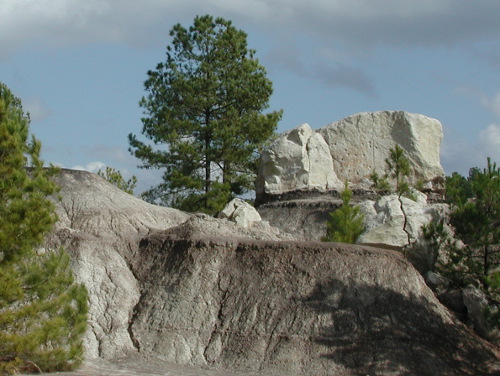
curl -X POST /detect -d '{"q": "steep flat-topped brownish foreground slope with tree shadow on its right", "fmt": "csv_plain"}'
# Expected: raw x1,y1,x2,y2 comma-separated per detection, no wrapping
131,234,496,375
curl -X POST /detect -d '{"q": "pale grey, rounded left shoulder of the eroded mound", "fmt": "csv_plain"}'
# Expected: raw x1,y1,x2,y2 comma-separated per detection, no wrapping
48,170,190,358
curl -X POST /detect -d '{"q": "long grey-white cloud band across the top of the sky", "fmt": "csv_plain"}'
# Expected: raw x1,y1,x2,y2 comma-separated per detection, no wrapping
0,0,500,98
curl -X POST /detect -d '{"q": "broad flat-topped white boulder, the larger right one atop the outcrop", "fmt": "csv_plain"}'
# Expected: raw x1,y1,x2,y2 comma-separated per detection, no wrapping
318,111,444,183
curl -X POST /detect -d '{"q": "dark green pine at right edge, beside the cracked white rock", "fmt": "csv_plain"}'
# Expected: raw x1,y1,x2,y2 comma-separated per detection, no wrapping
440,158,500,294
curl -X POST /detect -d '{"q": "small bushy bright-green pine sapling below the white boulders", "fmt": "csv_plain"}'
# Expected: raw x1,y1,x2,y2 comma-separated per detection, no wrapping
323,181,365,244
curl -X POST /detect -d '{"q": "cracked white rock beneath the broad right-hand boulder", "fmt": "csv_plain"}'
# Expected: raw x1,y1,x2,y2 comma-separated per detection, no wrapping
358,191,447,249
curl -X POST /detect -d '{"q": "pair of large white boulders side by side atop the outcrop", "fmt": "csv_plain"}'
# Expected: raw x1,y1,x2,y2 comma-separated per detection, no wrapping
256,111,444,200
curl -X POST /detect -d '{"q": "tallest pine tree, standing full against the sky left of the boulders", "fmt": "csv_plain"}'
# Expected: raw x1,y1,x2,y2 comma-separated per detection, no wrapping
129,15,281,213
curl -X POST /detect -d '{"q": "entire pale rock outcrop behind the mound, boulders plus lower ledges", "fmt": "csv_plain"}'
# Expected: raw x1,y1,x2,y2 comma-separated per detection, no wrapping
256,111,499,350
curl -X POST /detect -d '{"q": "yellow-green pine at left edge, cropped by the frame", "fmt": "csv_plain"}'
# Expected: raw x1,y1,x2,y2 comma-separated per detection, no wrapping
0,83,87,373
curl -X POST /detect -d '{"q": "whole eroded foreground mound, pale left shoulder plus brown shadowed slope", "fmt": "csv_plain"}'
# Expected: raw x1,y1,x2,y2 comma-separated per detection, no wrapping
44,171,500,376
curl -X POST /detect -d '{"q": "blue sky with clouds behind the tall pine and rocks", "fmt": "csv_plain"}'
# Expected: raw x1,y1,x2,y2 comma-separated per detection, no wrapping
0,0,500,193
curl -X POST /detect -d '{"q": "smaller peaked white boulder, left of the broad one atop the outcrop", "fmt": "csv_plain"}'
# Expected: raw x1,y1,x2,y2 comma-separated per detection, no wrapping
257,124,343,194
